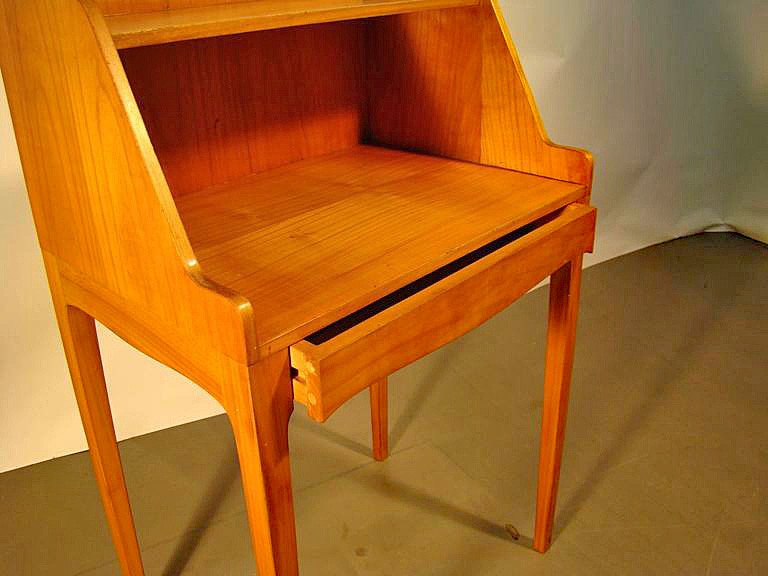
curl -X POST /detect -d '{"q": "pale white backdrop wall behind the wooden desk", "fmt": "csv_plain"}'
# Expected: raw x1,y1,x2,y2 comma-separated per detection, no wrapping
0,0,768,471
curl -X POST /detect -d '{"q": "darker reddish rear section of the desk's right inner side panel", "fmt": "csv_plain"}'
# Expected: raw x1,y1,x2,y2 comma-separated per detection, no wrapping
367,8,482,162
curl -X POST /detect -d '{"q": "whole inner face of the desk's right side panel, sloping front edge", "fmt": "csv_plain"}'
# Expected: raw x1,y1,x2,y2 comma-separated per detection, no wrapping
368,0,592,186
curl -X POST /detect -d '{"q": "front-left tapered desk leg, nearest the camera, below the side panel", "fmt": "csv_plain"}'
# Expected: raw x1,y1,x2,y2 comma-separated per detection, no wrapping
227,351,299,576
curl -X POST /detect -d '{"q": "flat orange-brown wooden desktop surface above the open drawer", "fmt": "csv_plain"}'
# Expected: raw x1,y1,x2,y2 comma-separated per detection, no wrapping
177,146,584,346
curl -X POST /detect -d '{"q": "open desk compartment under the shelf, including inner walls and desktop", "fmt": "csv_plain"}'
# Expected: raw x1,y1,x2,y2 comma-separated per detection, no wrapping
108,0,587,346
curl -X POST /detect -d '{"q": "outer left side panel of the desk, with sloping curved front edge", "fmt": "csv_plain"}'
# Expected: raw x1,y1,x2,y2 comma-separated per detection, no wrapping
0,0,253,360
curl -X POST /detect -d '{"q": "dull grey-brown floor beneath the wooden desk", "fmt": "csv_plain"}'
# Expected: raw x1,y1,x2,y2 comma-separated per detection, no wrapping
0,234,768,576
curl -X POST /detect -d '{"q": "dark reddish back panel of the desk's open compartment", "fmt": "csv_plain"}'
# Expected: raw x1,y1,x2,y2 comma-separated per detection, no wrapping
121,22,363,195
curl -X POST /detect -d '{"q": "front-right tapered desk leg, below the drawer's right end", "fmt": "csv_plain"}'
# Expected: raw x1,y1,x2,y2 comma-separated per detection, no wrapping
533,256,582,552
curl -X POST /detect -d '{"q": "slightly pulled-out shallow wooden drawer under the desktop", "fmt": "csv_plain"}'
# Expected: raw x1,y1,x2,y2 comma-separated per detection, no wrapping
290,204,595,422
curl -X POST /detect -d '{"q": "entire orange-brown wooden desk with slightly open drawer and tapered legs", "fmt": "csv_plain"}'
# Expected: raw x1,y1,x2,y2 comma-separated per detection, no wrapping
0,0,595,576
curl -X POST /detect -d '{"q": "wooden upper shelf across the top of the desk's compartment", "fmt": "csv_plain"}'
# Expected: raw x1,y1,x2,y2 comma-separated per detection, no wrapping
107,0,479,48
